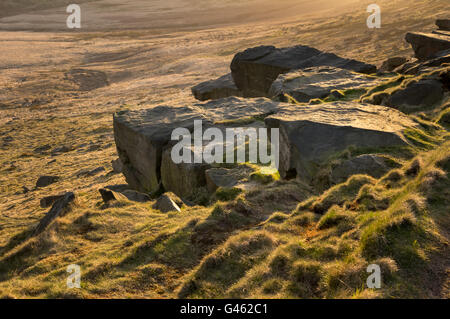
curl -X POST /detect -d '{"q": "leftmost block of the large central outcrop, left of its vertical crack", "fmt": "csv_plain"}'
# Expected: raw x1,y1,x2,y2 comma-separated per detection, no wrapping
114,106,206,192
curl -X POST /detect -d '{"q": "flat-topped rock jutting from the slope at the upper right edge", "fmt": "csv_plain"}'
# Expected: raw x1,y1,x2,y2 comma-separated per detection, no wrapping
405,32,450,60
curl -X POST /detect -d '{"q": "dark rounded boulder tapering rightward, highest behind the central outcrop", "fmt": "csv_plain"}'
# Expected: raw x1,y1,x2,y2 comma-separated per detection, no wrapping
231,46,376,97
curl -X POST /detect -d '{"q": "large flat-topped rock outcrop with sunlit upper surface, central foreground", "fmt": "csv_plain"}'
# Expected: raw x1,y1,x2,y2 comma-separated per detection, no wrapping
114,97,422,198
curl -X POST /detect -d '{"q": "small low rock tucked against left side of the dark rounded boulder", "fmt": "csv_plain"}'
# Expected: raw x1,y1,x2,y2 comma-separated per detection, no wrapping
192,73,242,101
